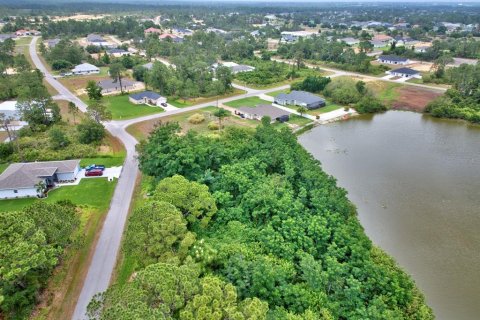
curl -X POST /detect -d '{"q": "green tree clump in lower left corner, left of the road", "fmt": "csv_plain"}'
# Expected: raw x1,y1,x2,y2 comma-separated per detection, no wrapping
0,201,80,319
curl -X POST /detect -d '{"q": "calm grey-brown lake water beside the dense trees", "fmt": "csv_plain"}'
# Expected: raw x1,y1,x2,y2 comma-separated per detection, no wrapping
299,111,480,320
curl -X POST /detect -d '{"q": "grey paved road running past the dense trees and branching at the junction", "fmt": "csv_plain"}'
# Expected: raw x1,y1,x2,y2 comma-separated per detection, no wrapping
29,37,289,320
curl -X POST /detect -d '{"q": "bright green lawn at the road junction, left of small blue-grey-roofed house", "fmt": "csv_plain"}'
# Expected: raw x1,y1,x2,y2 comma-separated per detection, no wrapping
103,94,164,120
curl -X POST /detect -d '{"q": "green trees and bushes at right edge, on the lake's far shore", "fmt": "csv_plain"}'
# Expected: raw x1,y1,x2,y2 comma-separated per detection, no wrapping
425,64,480,123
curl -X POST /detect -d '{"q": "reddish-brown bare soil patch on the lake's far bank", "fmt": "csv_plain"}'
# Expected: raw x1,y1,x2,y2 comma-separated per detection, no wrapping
392,86,442,112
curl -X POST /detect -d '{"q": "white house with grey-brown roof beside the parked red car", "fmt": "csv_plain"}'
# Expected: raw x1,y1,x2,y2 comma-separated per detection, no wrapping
0,160,80,199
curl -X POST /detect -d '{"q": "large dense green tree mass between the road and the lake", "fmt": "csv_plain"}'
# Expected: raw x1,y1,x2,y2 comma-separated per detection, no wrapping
90,121,433,319
